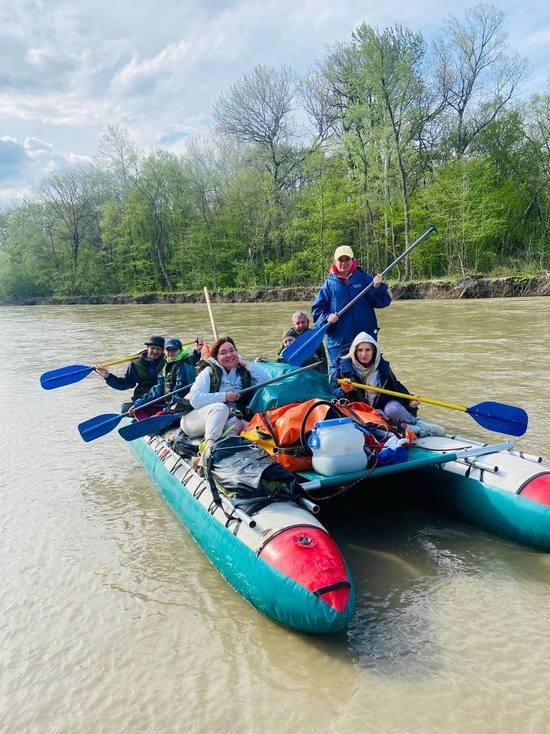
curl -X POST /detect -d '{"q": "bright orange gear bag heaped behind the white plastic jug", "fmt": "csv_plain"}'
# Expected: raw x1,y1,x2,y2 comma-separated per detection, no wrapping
241,398,412,472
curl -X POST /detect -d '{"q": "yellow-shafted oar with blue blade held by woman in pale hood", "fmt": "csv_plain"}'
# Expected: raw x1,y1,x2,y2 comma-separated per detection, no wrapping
338,380,529,436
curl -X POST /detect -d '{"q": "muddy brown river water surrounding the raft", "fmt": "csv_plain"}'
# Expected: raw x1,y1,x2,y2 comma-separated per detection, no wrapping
0,298,550,734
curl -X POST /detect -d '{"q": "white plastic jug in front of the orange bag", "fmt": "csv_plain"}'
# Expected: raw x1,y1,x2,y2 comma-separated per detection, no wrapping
308,418,368,477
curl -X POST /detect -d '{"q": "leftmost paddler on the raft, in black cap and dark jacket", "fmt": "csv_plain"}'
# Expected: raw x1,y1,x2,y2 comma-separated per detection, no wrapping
96,335,165,413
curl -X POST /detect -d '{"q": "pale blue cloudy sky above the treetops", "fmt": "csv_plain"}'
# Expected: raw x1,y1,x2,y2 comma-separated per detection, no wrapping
0,0,550,205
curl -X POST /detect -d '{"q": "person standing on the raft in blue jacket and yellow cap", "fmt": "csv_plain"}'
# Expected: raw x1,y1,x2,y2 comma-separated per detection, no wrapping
311,245,391,365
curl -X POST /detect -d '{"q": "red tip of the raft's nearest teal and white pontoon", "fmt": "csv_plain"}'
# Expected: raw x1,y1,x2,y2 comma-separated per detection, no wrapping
260,526,351,612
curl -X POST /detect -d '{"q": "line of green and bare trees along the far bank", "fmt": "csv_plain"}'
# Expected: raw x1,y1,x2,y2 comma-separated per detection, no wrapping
0,4,550,300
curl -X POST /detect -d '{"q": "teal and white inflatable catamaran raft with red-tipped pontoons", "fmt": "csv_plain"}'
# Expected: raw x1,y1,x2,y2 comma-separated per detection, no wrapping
118,365,550,634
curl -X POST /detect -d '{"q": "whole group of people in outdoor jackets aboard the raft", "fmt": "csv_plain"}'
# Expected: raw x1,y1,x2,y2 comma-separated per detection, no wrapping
97,245,445,454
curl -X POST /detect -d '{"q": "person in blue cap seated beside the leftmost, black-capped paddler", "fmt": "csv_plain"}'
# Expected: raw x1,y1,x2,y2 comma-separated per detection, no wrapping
130,337,203,417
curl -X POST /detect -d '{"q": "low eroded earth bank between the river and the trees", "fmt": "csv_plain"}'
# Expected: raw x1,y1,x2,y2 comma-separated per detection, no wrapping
1,273,550,306
